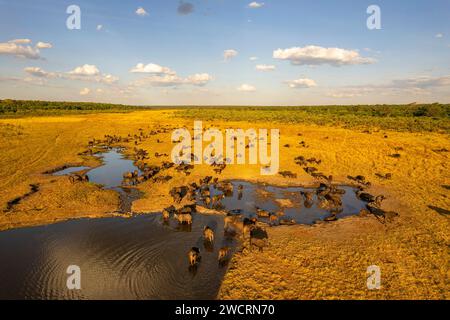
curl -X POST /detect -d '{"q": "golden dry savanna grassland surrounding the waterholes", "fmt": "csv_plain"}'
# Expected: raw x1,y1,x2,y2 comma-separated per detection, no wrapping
0,100,450,299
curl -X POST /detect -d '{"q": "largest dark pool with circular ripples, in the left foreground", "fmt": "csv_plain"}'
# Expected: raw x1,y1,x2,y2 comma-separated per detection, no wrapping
0,215,236,299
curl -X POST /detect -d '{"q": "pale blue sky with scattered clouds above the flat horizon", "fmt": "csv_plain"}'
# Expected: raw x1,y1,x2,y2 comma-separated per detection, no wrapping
0,0,450,105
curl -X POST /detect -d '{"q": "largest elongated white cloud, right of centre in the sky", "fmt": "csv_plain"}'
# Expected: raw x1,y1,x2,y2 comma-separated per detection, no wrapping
273,46,376,66
